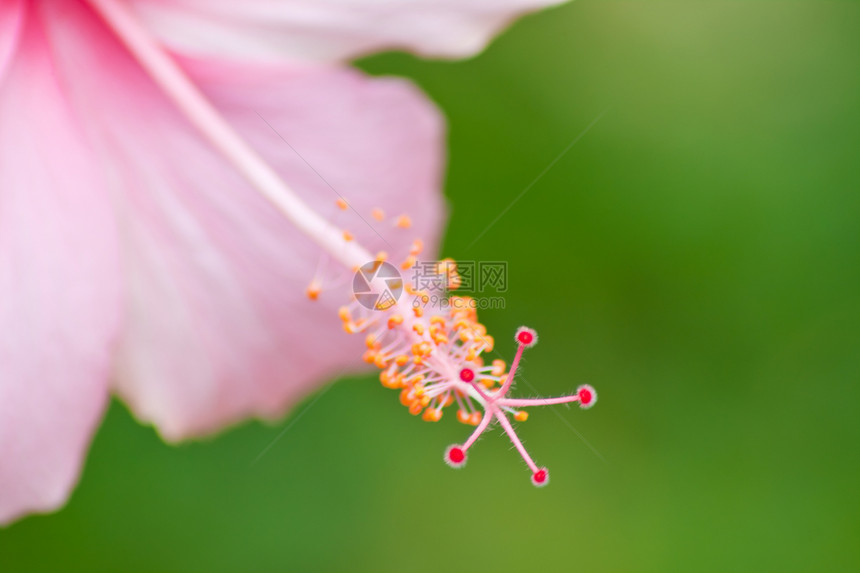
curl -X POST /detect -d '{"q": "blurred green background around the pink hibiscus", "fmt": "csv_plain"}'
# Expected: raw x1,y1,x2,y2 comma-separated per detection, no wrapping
0,0,860,572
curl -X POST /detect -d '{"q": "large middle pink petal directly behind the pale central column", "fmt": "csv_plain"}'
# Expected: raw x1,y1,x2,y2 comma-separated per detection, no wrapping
42,5,443,439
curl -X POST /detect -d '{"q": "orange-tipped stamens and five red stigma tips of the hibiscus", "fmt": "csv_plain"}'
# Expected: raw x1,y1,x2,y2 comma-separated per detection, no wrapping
334,250,597,487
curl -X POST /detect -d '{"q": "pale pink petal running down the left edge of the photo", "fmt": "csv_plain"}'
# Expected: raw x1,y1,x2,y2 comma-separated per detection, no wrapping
0,7,120,523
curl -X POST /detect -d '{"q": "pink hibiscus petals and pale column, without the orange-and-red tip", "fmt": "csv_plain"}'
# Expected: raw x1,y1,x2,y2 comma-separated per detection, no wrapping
0,0,572,523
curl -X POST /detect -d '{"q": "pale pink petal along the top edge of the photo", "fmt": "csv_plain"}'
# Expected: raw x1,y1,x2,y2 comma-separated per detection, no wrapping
124,0,561,61
